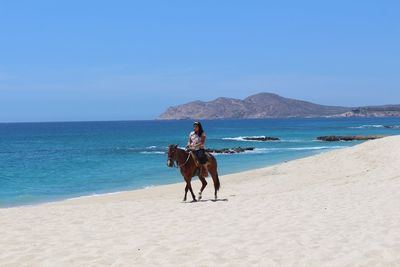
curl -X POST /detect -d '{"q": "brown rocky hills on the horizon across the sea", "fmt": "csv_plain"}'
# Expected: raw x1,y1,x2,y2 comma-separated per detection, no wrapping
158,93,400,120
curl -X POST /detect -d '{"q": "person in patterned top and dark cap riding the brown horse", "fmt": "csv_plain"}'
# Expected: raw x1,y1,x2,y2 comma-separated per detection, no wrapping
186,121,208,177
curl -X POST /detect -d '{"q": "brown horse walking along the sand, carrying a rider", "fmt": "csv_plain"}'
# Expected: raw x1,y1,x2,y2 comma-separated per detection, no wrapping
167,145,221,201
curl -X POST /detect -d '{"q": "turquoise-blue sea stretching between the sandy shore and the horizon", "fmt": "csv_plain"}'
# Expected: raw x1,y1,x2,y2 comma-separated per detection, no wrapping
0,118,400,207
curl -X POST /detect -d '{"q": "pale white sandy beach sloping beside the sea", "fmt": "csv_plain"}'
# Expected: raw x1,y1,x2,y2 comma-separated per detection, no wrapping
0,136,400,266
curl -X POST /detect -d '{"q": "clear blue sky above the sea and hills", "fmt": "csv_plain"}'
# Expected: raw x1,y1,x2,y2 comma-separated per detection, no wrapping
0,0,400,122
